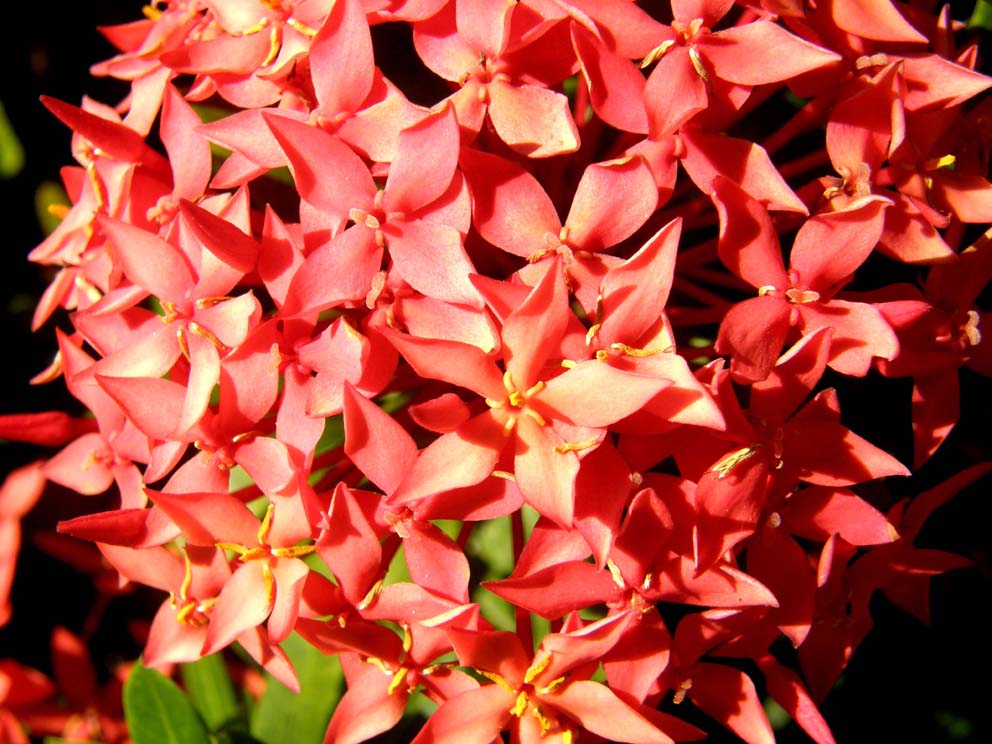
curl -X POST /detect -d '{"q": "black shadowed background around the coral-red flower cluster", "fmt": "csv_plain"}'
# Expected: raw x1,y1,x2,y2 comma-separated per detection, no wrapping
0,0,992,743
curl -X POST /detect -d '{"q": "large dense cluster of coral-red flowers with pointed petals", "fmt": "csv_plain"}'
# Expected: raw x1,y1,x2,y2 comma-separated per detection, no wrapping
0,0,992,744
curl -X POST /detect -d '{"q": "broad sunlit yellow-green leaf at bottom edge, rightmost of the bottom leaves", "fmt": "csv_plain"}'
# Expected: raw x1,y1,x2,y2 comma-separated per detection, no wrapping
251,633,344,744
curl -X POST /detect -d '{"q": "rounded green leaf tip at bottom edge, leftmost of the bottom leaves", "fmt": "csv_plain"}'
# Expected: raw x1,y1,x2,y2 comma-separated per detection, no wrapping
124,662,210,744
